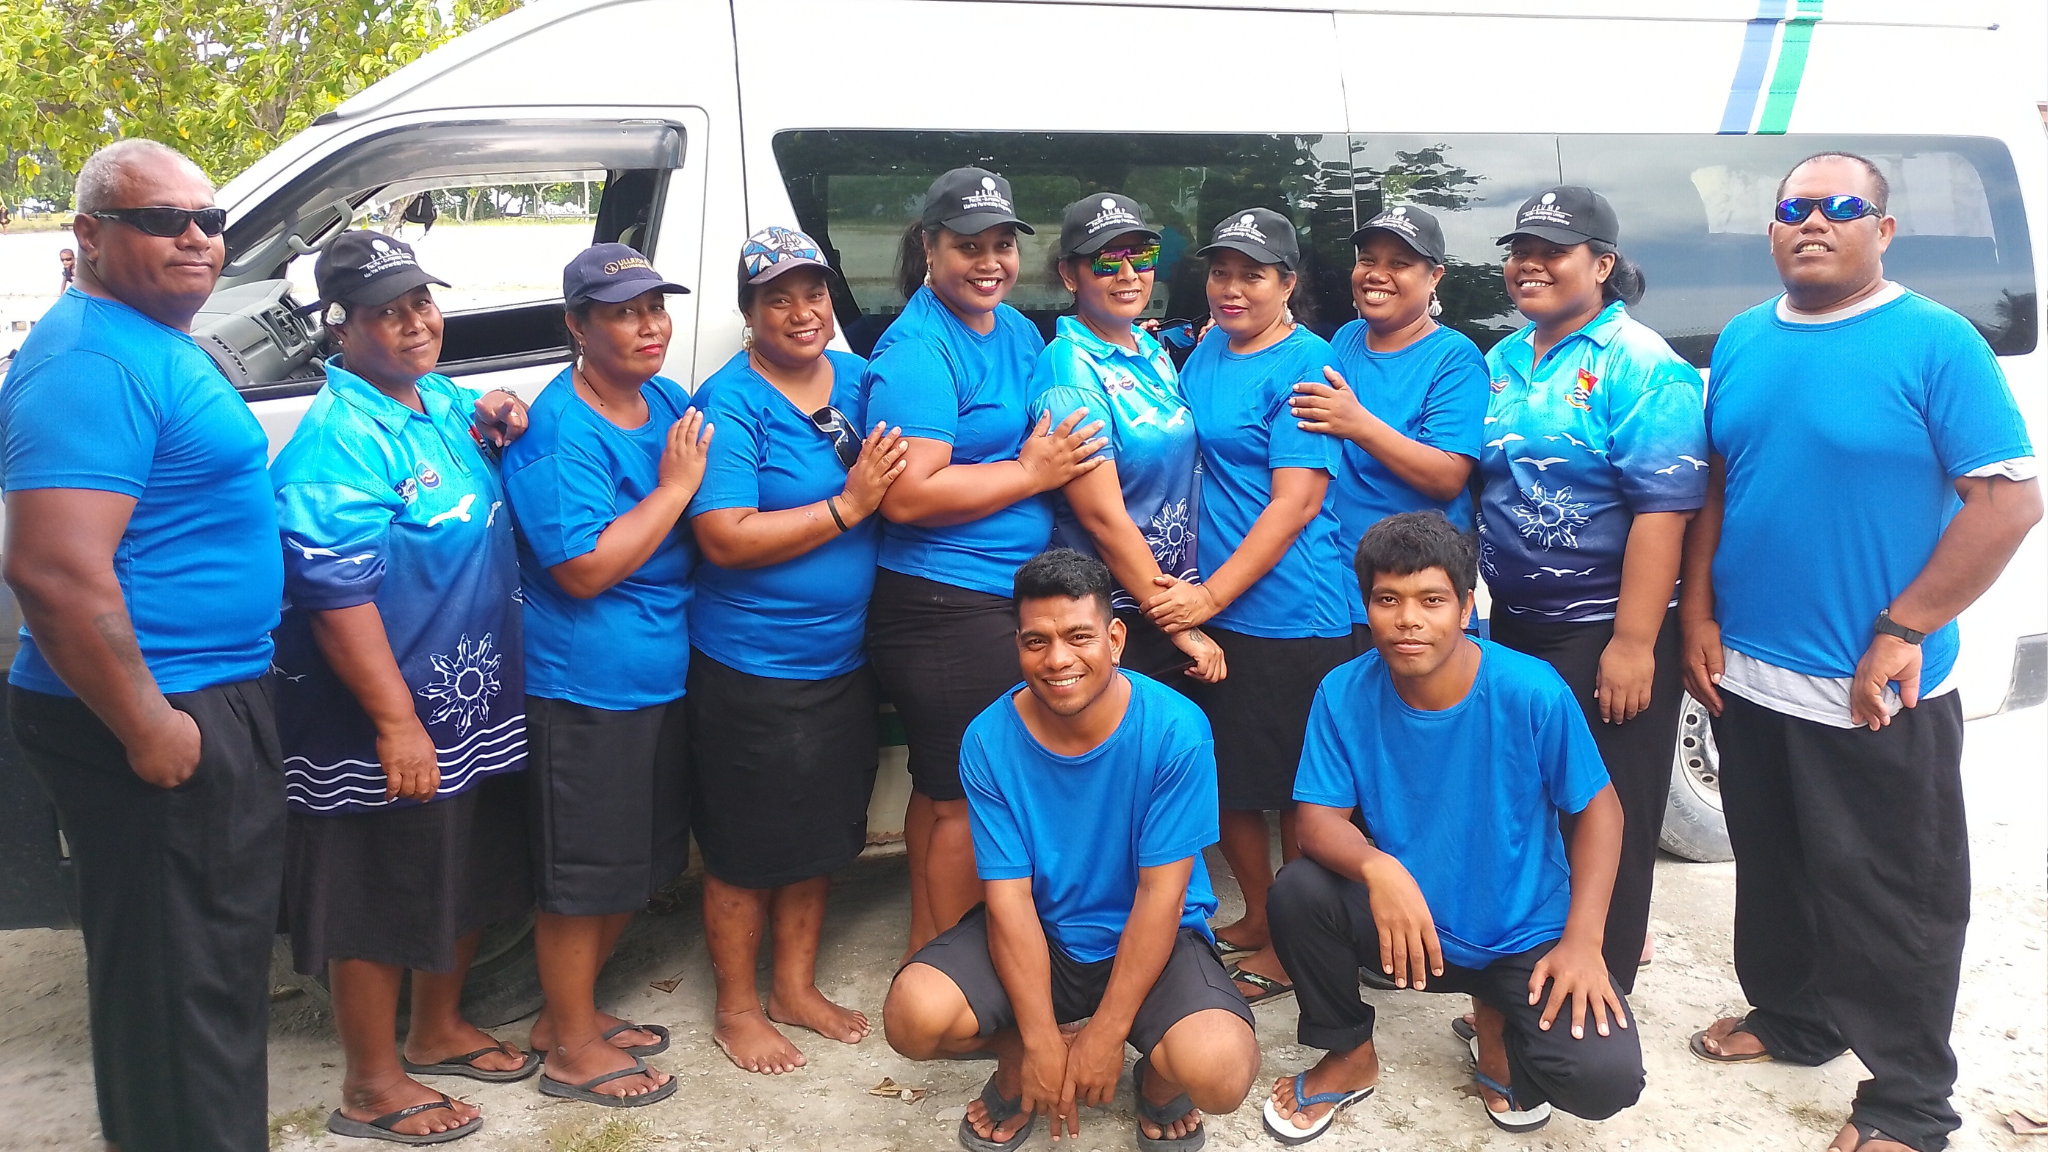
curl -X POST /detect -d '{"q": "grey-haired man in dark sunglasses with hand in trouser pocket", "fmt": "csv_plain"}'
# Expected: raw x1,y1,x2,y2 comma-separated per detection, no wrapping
0,139,285,1152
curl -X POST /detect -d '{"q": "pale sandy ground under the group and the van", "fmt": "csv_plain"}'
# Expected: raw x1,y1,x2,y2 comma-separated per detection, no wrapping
0,709,2048,1152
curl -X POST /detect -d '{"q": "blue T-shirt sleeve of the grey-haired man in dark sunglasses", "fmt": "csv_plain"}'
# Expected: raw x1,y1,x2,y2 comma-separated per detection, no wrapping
0,353,166,498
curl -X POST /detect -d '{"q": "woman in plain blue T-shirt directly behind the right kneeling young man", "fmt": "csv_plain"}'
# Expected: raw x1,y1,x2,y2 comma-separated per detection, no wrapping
1294,205,1487,639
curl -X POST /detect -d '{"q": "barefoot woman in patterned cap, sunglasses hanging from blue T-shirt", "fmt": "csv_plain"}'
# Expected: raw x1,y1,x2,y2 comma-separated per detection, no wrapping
686,228,907,1072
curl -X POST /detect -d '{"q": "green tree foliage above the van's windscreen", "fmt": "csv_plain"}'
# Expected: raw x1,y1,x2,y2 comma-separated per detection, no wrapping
0,0,522,199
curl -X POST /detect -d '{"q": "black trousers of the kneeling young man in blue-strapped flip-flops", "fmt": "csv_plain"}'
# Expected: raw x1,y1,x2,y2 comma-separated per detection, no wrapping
1266,857,1642,1119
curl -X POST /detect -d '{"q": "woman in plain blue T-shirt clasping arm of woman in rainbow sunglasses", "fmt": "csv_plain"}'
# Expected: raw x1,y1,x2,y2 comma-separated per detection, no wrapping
1145,207,1352,1000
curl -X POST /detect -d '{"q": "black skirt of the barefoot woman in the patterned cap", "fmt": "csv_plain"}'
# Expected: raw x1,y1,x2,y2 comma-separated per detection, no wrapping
684,652,881,888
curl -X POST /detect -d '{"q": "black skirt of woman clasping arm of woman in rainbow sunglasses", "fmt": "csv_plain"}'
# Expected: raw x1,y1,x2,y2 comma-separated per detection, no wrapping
1186,625,1352,812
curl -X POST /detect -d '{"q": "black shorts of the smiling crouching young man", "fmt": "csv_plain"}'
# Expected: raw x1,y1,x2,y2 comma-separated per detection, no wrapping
909,904,1257,1054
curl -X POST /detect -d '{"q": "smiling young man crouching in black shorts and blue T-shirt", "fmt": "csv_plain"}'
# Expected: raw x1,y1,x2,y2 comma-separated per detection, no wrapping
883,549,1261,1152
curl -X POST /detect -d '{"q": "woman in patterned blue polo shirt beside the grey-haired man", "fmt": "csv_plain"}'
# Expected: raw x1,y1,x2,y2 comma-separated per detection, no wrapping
270,232,541,1140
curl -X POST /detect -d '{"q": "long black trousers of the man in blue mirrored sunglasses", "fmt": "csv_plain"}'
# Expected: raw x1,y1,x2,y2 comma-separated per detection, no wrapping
1714,693,1970,1152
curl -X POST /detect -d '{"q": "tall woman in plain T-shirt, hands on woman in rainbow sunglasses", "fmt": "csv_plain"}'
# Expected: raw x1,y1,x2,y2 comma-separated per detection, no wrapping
864,168,1102,957
